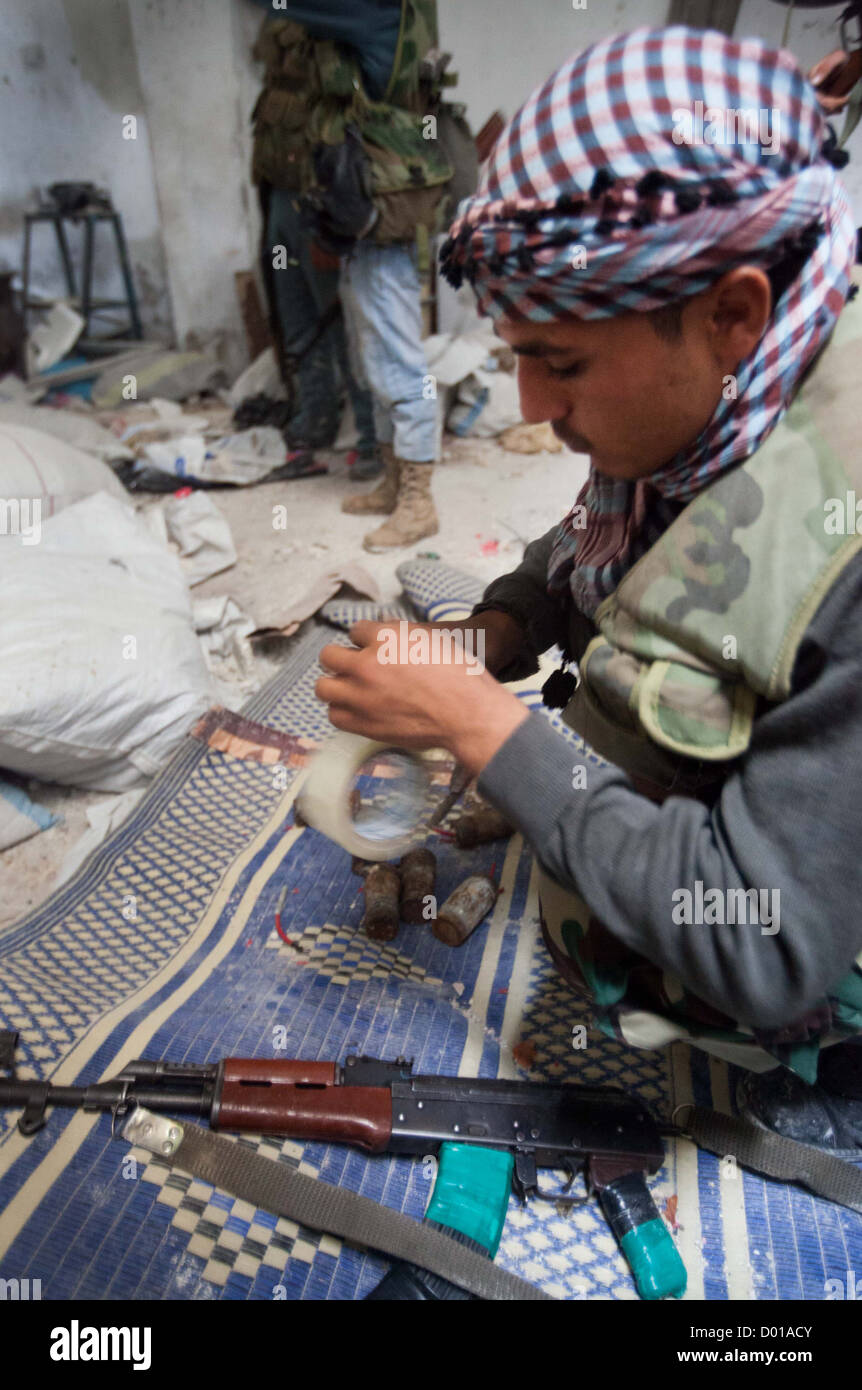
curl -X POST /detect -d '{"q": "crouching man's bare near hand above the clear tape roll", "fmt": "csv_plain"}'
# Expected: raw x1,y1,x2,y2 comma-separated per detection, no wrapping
316,613,528,777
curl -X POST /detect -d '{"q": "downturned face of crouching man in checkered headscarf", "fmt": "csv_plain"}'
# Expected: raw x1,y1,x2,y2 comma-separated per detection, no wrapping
496,267,770,478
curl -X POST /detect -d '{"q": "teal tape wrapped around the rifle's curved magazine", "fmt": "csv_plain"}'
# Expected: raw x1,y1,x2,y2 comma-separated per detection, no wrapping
425,1144,514,1259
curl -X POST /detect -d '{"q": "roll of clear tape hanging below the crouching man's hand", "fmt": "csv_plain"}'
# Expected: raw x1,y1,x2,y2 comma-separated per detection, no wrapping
298,733,430,862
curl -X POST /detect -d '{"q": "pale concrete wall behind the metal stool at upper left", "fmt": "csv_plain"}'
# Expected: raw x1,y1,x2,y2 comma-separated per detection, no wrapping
0,0,261,370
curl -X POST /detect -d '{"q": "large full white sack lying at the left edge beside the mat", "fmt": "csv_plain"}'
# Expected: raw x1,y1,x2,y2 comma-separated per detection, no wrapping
0,493,211,791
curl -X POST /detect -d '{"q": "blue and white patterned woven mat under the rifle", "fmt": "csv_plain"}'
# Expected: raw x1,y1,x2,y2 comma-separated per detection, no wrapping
0,560,862,1300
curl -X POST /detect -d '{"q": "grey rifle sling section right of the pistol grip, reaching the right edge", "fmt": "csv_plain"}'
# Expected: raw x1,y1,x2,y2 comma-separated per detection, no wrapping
681,1105,862,1212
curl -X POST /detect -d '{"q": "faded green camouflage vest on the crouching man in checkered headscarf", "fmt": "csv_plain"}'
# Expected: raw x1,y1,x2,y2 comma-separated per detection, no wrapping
564,287,862,791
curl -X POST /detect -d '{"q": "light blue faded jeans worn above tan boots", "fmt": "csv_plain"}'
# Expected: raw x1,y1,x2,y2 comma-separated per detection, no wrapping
341,242,437,463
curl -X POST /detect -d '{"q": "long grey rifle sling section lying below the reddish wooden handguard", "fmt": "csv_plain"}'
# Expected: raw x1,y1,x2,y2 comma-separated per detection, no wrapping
156,1120,551,1302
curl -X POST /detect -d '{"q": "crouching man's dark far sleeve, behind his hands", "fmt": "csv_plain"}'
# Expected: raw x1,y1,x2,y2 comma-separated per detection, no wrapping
473,524,567,681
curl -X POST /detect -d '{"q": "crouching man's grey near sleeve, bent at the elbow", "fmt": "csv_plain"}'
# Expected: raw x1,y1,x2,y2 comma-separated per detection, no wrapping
478,547,862,1029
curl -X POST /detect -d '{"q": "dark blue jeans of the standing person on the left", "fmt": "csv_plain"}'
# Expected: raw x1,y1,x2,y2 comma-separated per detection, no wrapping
264,188,375,453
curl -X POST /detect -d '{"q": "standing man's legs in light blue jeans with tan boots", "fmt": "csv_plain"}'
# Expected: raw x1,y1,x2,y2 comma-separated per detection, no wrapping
342,242,438,550
